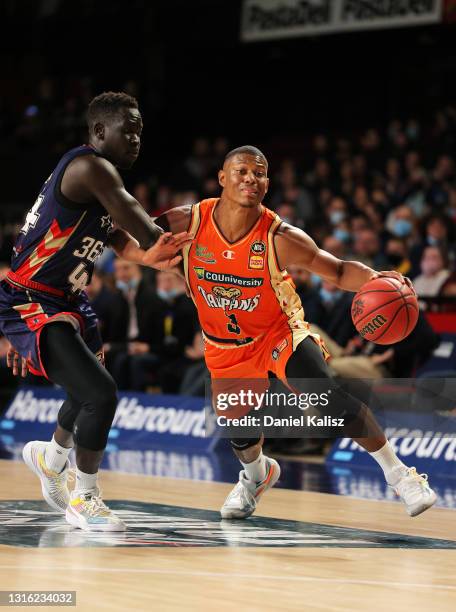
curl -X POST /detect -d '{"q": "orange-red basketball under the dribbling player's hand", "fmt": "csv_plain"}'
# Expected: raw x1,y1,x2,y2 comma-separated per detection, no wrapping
351,277,419,344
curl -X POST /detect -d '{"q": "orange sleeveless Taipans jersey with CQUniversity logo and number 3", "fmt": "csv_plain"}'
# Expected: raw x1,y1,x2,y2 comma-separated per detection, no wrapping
183,198,318,350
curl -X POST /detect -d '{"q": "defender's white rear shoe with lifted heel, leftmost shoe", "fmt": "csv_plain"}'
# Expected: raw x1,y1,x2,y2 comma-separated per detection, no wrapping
22,440,72,513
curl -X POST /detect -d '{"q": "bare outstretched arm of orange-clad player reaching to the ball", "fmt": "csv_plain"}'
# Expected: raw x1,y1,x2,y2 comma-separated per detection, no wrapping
274,223,407,292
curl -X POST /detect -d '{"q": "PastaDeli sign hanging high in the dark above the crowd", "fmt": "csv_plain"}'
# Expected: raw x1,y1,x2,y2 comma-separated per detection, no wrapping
241,0,442,42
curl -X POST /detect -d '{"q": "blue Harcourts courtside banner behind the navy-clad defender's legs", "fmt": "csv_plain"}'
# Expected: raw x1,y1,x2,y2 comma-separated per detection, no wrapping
0,387,216,450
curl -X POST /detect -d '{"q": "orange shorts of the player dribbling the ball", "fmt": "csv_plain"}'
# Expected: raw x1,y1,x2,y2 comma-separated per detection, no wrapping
205,324,329,418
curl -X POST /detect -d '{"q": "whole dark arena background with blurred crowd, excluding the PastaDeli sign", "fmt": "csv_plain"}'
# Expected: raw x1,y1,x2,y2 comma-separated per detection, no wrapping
0,0,456,452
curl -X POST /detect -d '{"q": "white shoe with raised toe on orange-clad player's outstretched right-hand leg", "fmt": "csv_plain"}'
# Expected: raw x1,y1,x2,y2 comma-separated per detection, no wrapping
390,466,437,516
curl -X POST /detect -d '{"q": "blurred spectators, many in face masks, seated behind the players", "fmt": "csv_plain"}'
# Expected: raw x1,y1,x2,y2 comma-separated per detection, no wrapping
0,83,456,416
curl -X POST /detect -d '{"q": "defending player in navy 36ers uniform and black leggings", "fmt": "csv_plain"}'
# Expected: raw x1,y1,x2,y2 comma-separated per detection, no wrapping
0,92,189,531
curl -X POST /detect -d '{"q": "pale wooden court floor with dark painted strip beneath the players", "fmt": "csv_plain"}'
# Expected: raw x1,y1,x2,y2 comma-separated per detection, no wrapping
0,461,456,611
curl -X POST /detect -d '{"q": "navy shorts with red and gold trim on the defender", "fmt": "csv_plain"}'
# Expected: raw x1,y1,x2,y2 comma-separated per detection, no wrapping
0,280,103,378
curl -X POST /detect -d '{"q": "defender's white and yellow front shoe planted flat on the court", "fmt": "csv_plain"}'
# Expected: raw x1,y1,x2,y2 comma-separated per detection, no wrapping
65,489,127,531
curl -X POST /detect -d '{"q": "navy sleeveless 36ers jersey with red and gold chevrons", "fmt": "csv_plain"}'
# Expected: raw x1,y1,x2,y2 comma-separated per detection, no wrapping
8,145,112,296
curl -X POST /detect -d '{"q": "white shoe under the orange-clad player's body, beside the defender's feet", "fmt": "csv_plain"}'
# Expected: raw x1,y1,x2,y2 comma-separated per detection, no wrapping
220,457,280,519
